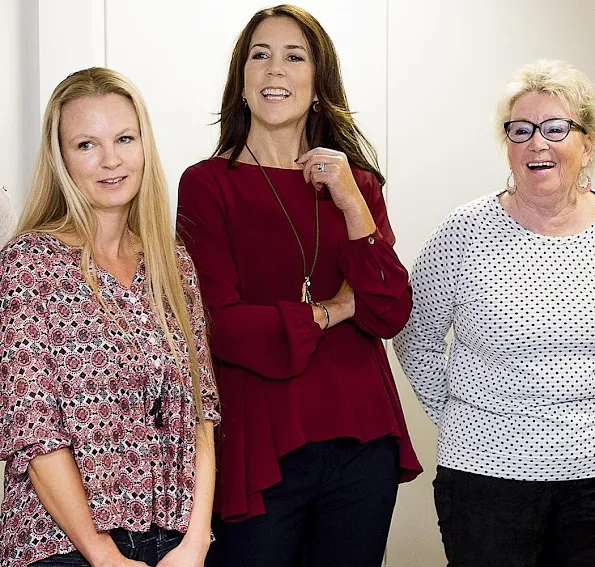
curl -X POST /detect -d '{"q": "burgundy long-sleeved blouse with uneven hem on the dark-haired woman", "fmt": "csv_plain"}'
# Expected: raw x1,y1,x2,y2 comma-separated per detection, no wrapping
178,158,421,520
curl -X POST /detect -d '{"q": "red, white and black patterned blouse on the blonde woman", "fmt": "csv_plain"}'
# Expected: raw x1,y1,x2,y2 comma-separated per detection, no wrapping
0,233,219,567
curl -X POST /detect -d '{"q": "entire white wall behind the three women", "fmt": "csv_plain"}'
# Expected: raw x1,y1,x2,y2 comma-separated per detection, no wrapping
0,0,595,567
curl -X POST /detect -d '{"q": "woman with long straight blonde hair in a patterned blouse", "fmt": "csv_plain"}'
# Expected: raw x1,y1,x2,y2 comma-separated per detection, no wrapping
0,68,219,567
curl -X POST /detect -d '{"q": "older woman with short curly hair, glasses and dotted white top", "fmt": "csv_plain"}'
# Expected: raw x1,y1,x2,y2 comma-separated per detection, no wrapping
394,60,595,567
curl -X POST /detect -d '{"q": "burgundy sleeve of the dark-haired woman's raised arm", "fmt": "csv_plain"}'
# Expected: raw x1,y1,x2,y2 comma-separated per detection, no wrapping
339,173,412,339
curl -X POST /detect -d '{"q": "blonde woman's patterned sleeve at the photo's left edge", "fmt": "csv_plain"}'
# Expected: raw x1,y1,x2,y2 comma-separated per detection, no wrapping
0,242,71,475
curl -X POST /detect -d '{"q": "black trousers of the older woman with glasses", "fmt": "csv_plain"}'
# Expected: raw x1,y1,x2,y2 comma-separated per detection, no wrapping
434,467,595,567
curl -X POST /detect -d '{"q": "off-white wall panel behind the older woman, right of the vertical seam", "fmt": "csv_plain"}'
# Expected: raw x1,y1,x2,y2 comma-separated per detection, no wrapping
388,0,595,567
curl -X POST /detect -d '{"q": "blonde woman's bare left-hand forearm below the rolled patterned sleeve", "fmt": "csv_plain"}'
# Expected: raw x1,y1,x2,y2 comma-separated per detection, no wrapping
28,449,121,567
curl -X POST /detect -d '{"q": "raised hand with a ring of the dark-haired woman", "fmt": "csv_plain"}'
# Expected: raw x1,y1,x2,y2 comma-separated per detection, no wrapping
296,148,363,213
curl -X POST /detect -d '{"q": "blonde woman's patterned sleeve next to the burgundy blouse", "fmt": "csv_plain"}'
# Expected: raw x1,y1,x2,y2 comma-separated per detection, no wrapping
179,248,221,425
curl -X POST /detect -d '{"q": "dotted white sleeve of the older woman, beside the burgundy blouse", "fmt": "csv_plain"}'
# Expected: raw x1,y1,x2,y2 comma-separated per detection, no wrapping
393,211,469,425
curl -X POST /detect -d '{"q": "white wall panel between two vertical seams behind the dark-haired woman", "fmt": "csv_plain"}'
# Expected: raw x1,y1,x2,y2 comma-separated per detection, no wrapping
105,0,387,222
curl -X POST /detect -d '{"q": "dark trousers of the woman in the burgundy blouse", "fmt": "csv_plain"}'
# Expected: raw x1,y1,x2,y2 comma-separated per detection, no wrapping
206,437,399,567
